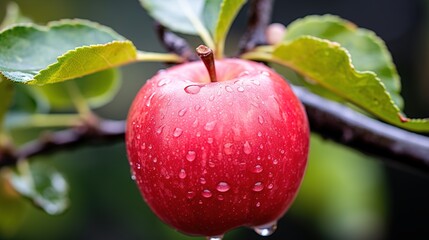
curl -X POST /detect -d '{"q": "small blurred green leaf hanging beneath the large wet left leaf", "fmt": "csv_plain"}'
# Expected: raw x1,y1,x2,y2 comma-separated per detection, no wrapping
32,68,121,110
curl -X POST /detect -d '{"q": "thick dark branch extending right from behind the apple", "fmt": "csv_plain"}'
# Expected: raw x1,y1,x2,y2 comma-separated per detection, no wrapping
294,87,429,174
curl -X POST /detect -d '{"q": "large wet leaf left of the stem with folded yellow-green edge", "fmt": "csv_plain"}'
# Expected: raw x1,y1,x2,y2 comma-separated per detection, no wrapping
0,20,137,85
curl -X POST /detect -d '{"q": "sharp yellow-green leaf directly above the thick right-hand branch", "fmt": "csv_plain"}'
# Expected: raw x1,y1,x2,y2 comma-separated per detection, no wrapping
242,36,429,132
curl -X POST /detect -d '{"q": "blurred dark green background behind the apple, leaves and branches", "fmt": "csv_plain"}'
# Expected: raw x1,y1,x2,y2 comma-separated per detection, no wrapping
0,0,429,240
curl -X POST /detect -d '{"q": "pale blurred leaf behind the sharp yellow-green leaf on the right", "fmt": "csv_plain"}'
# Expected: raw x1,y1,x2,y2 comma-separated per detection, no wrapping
284,15,403,109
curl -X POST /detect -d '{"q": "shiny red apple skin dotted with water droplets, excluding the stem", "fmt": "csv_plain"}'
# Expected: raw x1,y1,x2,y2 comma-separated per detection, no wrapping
126,59,309,236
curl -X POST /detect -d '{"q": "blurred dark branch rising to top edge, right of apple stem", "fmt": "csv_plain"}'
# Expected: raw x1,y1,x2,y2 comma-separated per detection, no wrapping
238,0,274,55
